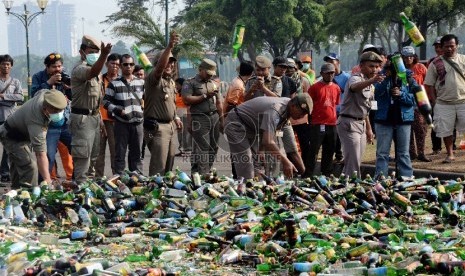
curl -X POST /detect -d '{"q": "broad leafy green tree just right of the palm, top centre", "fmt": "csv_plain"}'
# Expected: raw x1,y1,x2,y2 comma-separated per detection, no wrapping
175,0,325,59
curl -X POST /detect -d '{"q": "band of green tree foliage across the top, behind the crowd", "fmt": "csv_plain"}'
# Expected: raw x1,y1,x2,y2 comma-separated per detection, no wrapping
104,0,465,59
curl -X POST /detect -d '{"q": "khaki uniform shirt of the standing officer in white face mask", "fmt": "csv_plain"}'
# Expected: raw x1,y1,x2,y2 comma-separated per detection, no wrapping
71,61,102,110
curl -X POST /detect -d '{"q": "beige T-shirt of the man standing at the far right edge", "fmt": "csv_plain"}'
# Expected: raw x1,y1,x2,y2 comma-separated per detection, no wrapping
424,54,465,104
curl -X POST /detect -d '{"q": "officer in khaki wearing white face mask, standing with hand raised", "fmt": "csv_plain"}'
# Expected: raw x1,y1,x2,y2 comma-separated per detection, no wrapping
70,35,112,184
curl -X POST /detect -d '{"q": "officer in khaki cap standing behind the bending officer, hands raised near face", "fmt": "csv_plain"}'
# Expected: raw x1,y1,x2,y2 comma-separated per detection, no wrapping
244,56,283,101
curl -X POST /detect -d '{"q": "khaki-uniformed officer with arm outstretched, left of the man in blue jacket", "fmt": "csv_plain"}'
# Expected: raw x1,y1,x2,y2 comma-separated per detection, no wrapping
336,51,384,176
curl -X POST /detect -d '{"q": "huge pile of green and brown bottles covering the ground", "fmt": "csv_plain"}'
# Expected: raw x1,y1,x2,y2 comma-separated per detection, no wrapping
0,170,465,275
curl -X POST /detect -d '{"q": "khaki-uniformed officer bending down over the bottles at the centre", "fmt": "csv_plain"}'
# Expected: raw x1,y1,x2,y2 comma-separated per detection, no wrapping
225,93,313,179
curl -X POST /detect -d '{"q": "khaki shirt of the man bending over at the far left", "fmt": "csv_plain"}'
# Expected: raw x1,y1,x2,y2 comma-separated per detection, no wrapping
6,90,50,152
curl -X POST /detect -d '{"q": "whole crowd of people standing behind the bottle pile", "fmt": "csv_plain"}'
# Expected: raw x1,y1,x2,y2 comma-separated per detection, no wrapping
0,32,465,188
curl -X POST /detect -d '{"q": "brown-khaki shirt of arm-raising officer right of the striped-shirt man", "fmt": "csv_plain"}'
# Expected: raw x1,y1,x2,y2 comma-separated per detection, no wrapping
144,73,176,121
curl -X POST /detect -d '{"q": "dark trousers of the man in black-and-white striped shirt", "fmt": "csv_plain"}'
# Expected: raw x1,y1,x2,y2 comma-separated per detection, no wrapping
114,121,144,174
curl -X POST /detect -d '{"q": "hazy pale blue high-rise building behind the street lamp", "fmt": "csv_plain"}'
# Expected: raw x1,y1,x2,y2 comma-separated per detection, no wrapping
7,1,79,57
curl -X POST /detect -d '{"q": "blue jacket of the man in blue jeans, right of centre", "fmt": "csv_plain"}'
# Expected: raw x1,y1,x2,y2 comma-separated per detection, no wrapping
375,74,418,123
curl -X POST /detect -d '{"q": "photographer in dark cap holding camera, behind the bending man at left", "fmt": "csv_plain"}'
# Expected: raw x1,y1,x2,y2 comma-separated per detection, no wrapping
31,53,73,181
